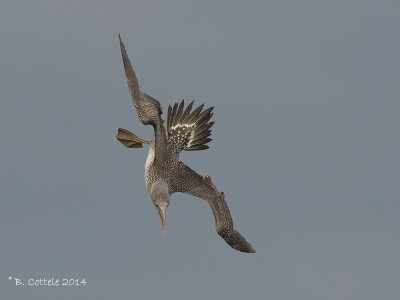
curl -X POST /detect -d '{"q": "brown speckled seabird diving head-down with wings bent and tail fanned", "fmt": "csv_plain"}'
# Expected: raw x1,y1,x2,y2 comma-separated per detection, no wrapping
115,35,255,253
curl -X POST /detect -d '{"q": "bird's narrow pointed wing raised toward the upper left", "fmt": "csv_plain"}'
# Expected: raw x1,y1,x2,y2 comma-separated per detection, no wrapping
119,35,162,125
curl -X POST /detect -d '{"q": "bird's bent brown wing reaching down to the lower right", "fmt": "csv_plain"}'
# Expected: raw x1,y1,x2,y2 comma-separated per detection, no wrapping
171,162,256,253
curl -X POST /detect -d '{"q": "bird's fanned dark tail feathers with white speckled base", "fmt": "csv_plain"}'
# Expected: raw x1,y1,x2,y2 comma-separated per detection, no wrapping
167,100,214,151
